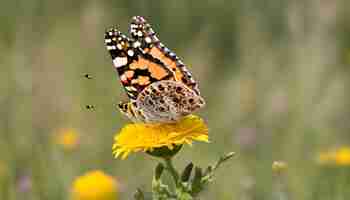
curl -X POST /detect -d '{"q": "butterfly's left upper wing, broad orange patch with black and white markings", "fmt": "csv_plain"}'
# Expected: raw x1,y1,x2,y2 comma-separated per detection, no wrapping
105,29,173,100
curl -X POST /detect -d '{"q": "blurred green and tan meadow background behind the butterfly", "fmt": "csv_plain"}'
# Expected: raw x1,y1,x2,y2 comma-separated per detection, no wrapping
0,0,350,200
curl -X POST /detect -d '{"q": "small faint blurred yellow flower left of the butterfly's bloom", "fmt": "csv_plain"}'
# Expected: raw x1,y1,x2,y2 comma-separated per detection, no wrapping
55,129,79,150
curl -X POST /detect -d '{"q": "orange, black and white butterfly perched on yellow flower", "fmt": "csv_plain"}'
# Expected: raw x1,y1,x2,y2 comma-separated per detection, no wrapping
105,16,205,123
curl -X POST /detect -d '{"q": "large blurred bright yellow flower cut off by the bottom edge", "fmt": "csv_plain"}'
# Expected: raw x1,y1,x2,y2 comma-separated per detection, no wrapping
71,170,118,200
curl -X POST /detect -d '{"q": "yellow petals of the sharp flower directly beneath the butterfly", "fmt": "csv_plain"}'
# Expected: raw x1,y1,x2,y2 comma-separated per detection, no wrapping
113,115,209,159
